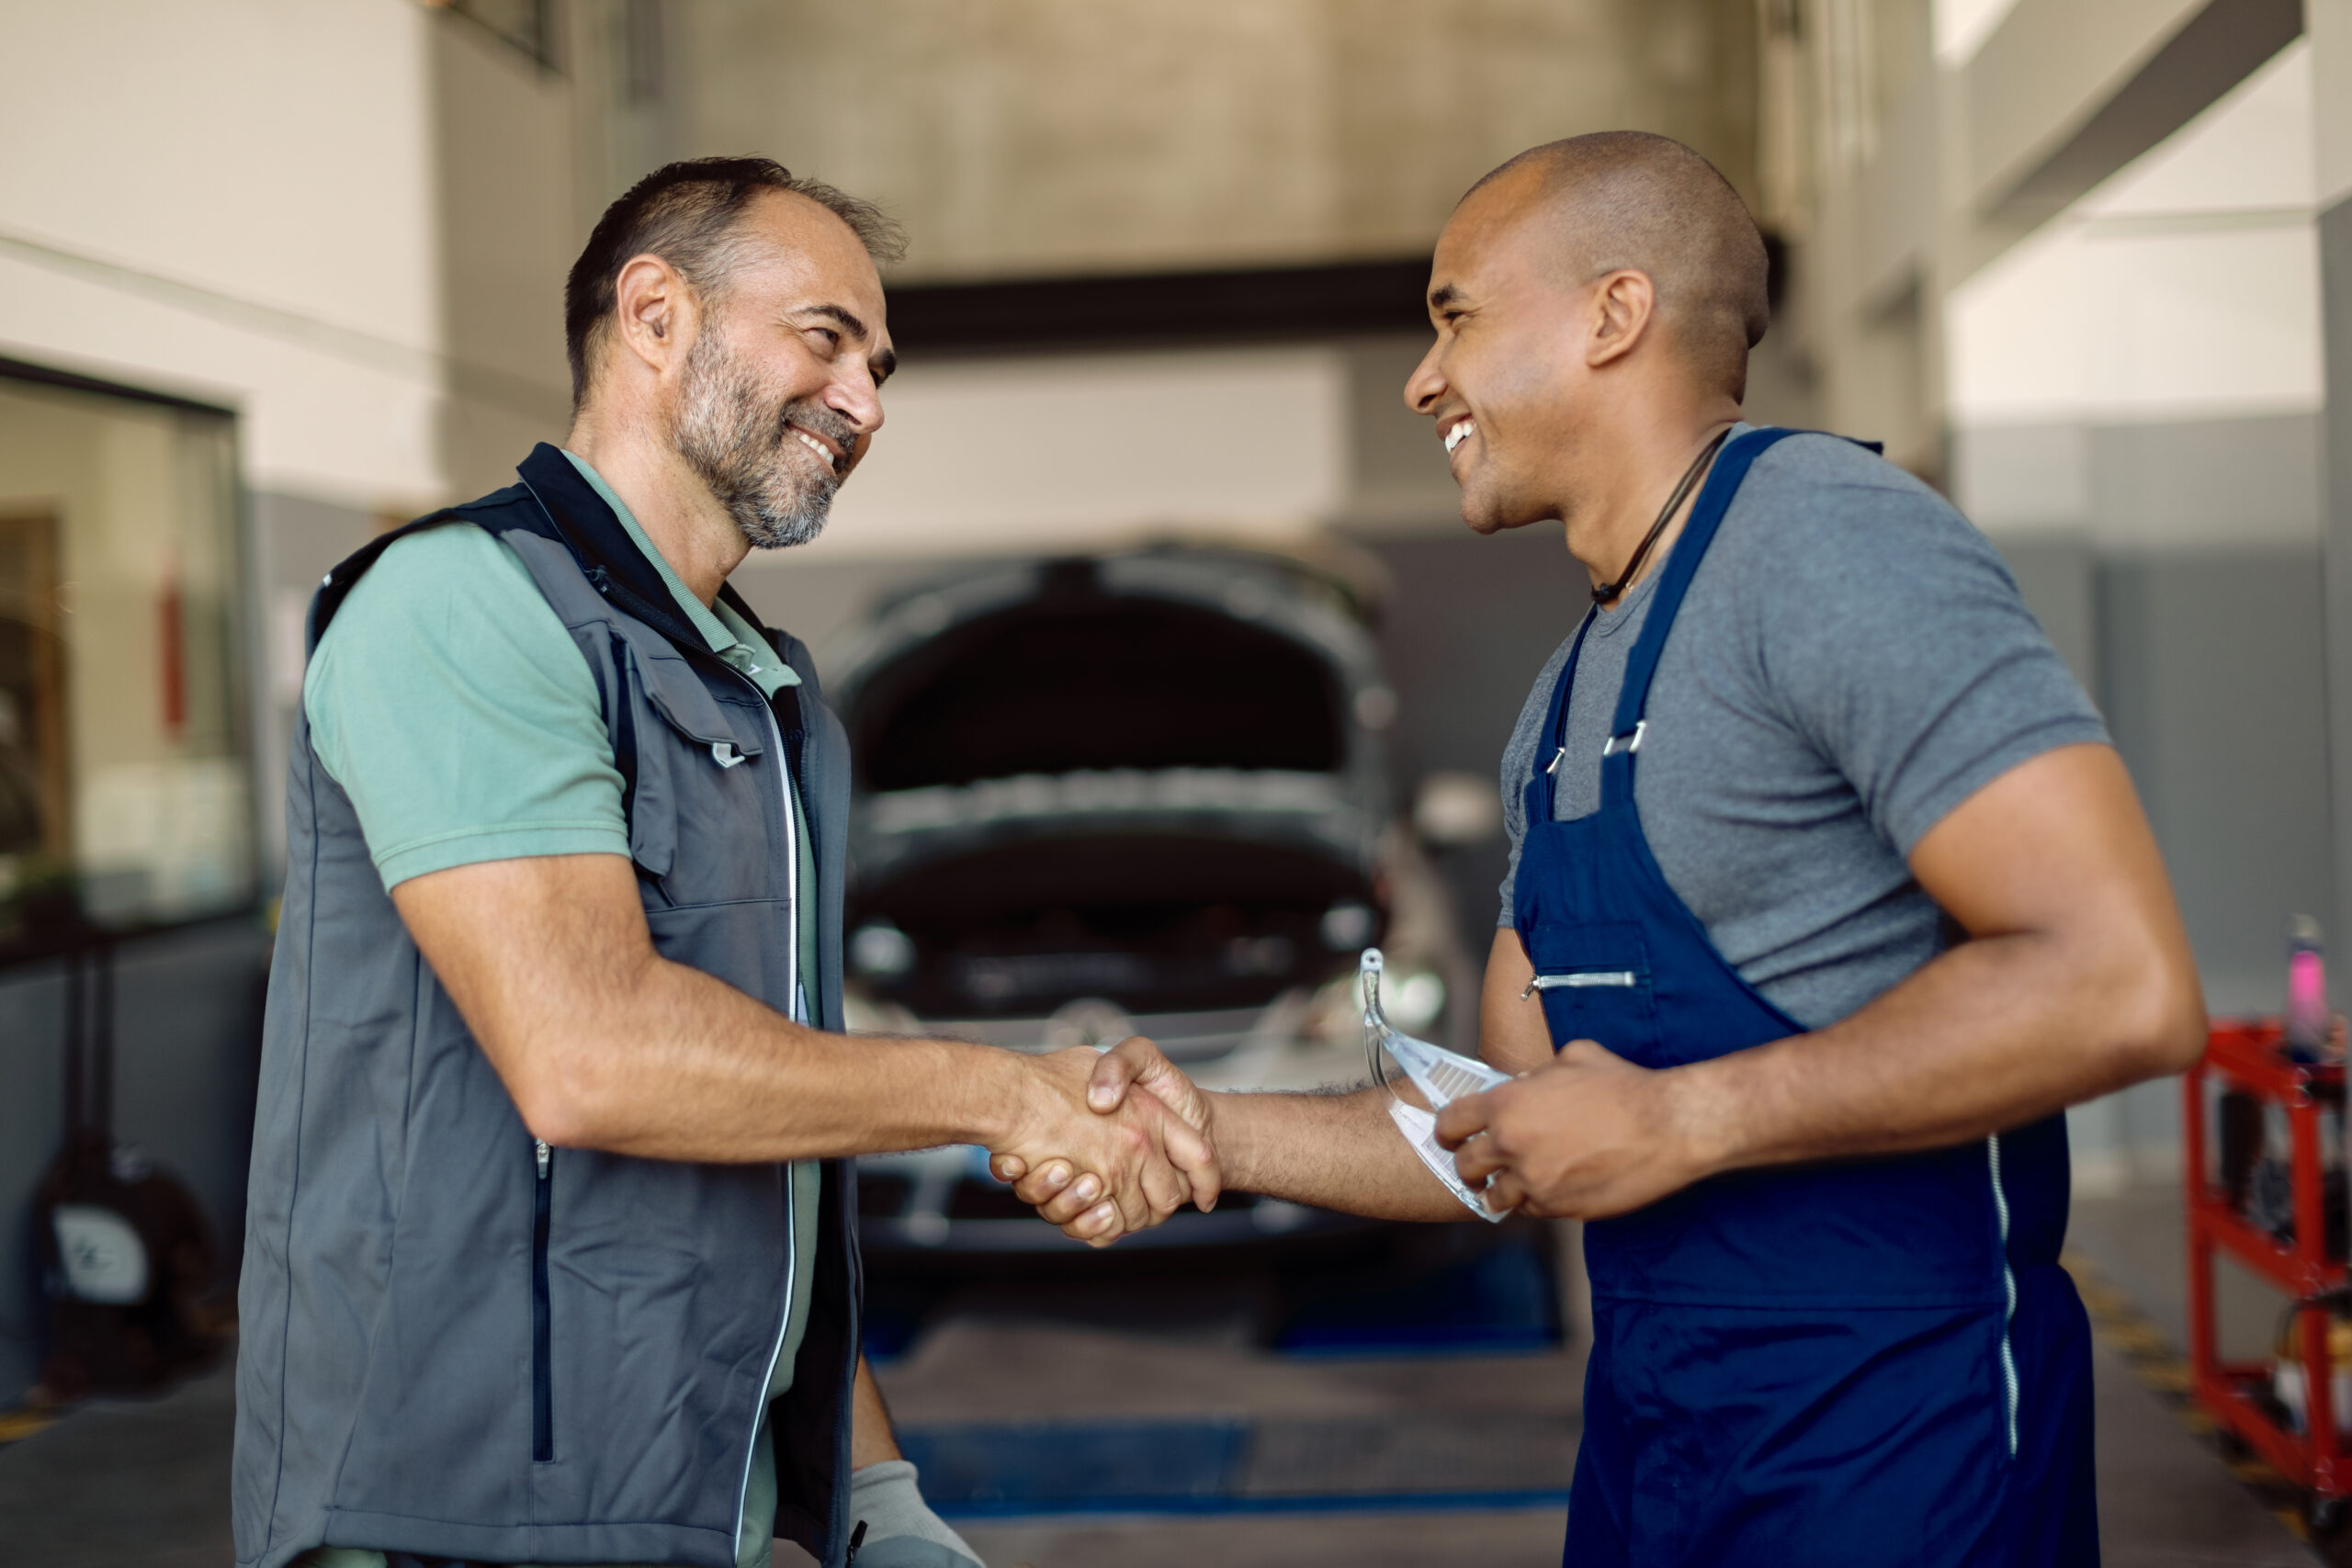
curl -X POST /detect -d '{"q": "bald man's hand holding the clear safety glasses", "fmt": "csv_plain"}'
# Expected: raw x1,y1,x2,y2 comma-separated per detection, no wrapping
1437,1039,1710,1220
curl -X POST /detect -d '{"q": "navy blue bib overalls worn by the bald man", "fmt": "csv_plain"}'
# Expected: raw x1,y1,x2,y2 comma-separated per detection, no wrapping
1515,430,2098,1568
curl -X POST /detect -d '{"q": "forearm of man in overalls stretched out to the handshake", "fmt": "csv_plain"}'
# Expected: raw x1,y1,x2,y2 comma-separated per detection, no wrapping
1209,1089,1470,1220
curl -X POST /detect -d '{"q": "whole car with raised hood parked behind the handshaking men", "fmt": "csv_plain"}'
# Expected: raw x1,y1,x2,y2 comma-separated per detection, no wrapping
828,547,1470,1253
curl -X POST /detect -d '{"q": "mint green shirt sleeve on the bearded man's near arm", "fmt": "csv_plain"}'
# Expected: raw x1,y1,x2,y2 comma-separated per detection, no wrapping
303,525,628,888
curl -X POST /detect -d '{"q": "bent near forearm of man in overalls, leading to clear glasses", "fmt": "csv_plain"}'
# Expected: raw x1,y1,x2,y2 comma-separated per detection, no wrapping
1668,933,2201,1170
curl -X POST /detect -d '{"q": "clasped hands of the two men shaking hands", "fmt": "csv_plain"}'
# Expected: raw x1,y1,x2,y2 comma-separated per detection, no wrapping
988,1034,1226,1246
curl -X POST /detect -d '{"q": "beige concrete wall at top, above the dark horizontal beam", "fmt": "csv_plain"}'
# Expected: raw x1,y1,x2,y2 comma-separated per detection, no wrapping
653,0,1755,277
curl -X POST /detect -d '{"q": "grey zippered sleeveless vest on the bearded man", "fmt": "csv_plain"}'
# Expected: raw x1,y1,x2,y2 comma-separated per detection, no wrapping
232,446,861,1568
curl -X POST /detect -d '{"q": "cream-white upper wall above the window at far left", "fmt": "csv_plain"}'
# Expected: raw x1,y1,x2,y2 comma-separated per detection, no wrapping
0,0,442,508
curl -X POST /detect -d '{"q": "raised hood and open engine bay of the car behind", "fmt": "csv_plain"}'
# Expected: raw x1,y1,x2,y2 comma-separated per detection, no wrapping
831,550,1395,1018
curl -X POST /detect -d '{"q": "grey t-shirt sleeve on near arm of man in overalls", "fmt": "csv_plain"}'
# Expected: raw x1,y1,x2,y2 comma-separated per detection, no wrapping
1740,463,2108,856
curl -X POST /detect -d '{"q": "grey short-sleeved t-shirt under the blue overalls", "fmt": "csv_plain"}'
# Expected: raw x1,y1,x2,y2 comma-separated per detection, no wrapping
1500,425,2108,1043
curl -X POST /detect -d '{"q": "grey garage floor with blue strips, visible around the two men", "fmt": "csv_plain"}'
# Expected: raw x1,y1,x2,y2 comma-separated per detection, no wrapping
0,1192,2317,1568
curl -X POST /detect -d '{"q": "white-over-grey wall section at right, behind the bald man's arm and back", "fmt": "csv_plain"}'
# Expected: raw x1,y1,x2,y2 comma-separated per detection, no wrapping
1943,45,2343,1187
